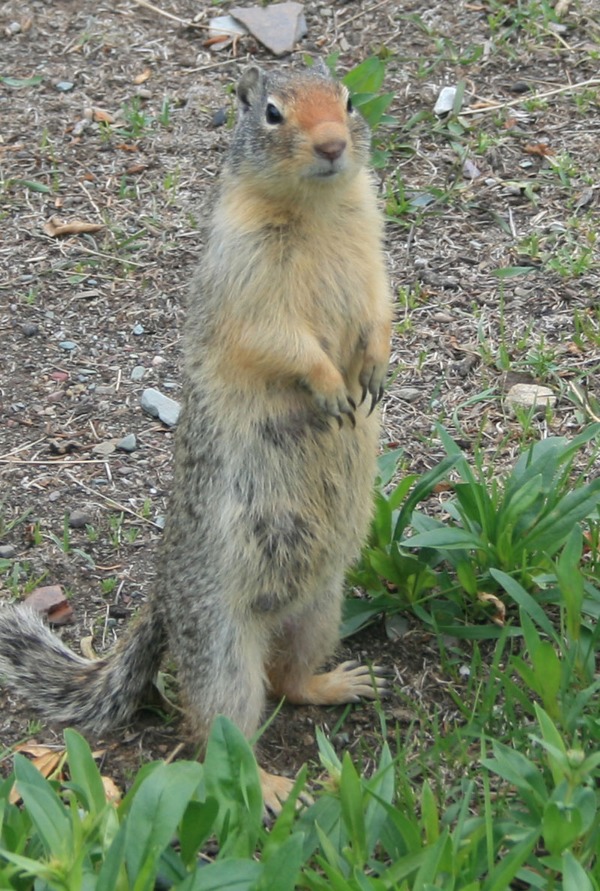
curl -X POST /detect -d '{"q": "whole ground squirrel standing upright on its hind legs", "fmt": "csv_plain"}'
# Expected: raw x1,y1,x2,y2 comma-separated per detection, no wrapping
0,66,391,806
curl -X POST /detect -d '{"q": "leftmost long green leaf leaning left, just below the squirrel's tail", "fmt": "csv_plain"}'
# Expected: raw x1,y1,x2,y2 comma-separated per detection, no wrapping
14,754,73,859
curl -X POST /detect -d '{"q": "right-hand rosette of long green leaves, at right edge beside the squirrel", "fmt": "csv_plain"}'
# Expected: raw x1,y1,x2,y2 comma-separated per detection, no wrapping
400,424,600,596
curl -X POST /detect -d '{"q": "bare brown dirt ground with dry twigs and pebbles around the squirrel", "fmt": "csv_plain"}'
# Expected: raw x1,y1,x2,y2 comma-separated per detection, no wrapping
0,0,600,782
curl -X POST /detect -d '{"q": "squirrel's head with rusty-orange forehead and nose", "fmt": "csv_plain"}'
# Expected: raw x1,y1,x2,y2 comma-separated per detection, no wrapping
229,65,370,190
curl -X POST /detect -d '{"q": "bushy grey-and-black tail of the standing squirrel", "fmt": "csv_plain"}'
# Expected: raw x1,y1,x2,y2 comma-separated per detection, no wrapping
0,604,166,733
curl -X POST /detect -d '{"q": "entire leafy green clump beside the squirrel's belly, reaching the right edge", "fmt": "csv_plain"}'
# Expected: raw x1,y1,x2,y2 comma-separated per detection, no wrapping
344,424,600,634
